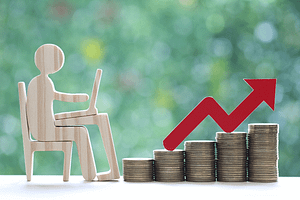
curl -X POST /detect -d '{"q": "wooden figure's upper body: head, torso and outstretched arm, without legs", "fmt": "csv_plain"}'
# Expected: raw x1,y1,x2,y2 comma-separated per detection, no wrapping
27,44,88,141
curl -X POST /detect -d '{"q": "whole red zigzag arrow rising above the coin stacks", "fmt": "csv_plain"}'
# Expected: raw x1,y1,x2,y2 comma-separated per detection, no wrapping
163,79,276,151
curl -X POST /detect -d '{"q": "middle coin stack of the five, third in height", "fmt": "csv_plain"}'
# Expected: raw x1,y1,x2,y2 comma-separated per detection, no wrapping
184,140,216,182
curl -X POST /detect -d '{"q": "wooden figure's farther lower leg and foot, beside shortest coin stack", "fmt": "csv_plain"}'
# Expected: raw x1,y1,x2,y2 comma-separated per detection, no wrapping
96,113,120,181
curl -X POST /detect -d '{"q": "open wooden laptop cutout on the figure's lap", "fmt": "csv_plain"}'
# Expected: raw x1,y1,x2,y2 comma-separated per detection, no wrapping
54,69,102,120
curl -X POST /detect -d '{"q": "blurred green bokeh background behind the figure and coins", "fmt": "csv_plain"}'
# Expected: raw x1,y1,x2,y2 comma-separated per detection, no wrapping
0,0,300,176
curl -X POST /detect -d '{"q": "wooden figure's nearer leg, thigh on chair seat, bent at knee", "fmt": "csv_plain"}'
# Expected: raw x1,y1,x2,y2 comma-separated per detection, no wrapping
55,126,96,181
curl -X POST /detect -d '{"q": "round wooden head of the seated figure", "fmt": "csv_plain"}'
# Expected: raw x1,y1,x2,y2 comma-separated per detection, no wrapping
34,44,65,75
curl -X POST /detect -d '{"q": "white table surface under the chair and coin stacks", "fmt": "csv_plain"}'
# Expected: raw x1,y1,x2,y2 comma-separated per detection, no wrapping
0,175,300,200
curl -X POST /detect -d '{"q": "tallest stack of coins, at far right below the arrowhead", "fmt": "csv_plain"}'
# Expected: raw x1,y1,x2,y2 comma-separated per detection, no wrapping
248,123,279,182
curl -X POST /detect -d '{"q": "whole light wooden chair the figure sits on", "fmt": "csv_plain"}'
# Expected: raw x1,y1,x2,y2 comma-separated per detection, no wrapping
18,82,72,181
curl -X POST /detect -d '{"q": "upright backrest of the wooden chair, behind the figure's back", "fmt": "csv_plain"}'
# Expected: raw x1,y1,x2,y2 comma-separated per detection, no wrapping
18,82,30,144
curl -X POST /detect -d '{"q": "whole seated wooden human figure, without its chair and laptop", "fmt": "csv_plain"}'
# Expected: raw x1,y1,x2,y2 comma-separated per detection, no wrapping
27,44,119,181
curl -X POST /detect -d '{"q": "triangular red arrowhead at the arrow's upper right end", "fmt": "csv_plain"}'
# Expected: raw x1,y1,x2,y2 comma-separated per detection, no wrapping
244,79,276,110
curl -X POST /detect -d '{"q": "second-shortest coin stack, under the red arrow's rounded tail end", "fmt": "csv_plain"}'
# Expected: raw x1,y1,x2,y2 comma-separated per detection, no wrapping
153,149,184,182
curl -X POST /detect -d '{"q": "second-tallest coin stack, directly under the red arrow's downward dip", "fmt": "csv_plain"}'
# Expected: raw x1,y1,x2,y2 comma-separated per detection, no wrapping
216,132,247,182
